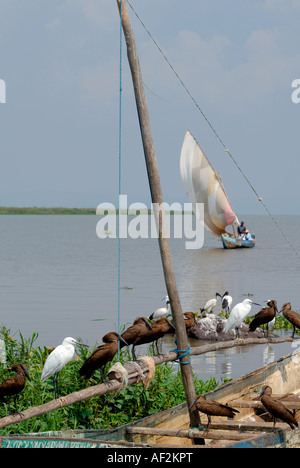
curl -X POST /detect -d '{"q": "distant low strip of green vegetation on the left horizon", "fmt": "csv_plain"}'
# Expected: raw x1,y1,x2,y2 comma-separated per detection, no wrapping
0,206,96,215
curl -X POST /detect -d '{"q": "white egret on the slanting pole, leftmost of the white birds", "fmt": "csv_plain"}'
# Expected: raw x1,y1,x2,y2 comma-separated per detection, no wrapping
41,336,89,399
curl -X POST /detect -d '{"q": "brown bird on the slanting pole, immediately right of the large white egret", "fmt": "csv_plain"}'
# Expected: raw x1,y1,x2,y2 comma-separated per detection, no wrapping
79,332,127,380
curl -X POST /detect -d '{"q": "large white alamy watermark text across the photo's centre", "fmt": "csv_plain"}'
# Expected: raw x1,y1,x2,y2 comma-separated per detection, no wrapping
96,195,204,249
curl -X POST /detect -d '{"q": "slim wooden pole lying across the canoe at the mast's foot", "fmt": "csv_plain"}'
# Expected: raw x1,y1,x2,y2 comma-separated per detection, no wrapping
127,427,253,440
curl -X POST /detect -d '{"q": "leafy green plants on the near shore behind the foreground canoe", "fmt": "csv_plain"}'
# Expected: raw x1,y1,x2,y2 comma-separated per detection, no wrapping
0,327,218,435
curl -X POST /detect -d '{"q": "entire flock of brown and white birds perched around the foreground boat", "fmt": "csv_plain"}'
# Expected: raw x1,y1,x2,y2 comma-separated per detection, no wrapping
0,291,300,429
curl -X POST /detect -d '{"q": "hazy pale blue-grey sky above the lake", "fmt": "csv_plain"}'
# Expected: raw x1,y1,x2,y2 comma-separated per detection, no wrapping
0,0,300,215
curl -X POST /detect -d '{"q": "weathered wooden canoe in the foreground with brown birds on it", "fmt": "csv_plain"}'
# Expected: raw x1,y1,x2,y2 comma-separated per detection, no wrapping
0,353,300,449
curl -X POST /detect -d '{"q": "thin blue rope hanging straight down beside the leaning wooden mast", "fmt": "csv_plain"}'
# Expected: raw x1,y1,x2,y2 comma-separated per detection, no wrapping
118,0,123,361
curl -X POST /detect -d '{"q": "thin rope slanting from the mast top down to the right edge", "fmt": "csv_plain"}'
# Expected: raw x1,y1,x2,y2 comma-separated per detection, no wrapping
127,0,300,260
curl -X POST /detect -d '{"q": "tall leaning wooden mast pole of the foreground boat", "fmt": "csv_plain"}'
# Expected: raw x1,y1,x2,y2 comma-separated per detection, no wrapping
117,0,205,445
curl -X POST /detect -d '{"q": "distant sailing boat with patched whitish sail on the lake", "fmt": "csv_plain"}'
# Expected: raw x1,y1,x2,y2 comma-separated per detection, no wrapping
180,130,255,249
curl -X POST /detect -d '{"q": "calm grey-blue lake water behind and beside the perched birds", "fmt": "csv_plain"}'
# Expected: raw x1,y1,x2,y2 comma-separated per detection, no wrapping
0,215,300,381
